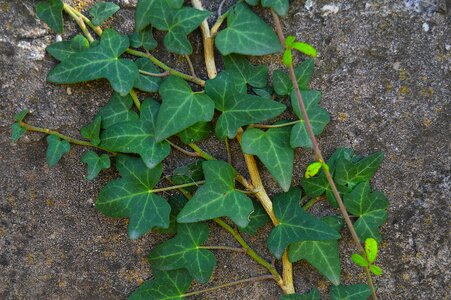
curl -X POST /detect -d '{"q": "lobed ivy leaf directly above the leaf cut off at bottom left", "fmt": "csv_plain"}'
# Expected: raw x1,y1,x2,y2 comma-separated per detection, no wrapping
149,223,216,283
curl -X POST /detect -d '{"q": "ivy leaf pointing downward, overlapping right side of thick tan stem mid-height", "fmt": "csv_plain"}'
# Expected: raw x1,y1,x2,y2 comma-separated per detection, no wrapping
241,127,294,192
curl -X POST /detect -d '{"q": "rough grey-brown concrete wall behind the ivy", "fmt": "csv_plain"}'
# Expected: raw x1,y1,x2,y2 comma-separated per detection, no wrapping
0,0,451,299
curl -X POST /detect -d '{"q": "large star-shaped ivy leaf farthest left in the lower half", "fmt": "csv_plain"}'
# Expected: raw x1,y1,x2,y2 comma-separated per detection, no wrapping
96,155,171,240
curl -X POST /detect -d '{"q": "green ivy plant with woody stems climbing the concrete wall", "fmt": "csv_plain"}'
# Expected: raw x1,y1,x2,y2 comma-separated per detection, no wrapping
12,0,388,300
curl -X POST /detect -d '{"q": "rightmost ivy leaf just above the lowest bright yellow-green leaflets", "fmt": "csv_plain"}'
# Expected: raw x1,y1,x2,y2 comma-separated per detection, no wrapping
344,181,388,242
